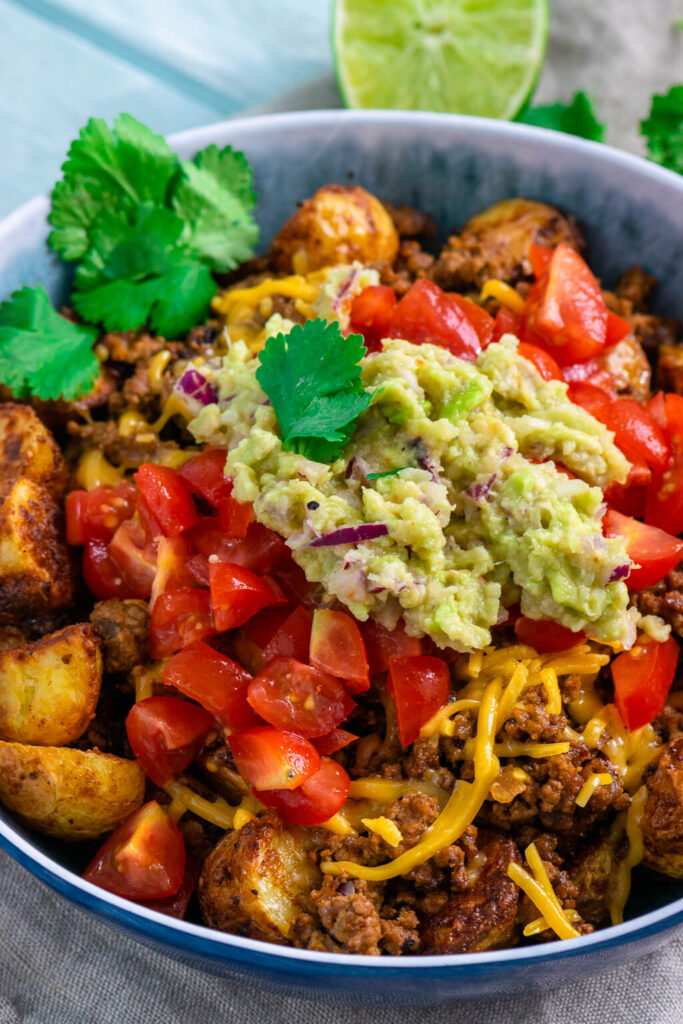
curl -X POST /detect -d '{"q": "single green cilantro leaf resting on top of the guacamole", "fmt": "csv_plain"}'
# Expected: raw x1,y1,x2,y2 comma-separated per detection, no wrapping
256,319,373,462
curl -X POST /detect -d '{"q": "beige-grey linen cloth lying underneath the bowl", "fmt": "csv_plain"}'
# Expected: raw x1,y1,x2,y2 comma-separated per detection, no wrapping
0,0,683,1024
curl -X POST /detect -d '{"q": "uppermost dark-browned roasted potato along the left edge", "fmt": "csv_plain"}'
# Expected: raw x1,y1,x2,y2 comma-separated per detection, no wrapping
0,401,67,498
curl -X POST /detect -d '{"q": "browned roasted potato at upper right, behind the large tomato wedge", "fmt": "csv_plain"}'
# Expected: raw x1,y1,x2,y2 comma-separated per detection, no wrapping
430,199,583,291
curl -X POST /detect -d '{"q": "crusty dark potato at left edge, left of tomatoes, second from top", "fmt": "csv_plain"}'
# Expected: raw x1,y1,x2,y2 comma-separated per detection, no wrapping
0,476,74,625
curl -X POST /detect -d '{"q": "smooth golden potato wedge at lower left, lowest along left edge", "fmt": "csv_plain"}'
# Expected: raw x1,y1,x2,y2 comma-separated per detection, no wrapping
0,741,144,841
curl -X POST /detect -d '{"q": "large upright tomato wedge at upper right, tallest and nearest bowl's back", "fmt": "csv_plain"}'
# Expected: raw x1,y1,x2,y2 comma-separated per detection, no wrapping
523,242,607,366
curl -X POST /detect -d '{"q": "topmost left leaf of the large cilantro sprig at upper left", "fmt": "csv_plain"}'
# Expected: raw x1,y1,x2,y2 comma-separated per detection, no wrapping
49,114,178,260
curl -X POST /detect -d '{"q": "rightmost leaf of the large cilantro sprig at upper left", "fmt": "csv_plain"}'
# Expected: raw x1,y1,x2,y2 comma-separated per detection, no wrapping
172,145,258,270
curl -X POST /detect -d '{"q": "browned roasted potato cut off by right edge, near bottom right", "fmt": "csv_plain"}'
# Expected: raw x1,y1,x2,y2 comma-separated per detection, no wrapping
641,736,683,879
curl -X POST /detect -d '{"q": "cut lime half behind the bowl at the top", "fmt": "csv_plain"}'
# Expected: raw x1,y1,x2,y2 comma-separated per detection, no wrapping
333,0,549,118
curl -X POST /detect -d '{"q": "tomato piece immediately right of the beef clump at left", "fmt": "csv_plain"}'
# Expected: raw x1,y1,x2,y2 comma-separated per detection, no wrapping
150,587,216,658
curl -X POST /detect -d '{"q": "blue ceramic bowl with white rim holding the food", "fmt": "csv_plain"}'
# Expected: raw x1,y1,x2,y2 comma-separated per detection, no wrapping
0,111,683,1006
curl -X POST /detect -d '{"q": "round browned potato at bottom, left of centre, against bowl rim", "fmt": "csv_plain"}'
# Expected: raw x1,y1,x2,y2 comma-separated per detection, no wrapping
199,811,321,944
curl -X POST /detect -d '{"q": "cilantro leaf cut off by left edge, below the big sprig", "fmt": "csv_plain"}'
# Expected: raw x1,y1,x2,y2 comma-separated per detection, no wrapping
0,286,99,401
